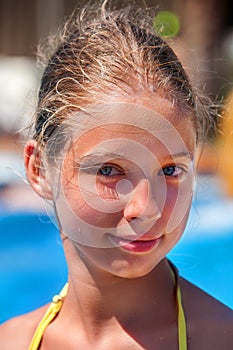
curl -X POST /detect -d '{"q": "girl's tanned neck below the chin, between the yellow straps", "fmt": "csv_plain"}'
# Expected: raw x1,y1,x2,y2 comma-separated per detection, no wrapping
62,241,176,331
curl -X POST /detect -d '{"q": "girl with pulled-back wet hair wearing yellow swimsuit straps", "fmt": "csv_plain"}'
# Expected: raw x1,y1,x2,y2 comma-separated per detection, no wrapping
0,1,233,350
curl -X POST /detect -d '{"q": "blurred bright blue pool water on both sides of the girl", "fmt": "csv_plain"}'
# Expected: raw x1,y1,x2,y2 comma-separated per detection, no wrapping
0,179,233,323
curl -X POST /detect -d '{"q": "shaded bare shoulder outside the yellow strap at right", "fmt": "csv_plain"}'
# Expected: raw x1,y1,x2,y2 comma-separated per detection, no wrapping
180,278,233,350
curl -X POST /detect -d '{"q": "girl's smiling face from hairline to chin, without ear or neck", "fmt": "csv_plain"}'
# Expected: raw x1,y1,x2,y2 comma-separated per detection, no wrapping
53,97,195,278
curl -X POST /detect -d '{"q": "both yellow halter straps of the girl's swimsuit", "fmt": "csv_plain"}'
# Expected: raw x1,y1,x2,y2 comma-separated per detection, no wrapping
28,265,187,350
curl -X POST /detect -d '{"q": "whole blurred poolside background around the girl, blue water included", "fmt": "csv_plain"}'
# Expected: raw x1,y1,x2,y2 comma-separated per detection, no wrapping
0,0,233,323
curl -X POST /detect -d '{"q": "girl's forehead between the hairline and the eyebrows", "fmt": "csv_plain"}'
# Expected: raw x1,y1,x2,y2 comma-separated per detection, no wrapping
68,98,196,154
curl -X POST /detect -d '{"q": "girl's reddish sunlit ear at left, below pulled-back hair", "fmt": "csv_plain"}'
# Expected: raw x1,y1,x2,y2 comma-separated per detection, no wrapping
24,140,53,199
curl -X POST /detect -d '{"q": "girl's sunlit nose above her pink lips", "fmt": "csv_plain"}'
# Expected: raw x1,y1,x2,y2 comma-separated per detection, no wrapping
124,179,161,222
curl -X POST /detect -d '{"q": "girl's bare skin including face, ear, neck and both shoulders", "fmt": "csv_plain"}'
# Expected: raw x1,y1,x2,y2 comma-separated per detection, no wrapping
0,94,232,350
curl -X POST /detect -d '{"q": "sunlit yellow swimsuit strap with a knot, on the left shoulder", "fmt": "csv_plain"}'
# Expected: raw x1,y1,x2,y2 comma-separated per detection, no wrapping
28,283,68,350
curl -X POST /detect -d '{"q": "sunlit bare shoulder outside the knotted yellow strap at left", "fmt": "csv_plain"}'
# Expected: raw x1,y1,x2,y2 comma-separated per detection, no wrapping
0,305,48,350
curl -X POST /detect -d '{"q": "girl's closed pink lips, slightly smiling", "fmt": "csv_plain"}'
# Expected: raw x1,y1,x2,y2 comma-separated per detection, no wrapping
109,235,161,253
